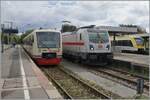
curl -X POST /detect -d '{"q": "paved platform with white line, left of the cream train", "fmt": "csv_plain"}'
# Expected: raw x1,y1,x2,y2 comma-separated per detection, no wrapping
0,45,62,99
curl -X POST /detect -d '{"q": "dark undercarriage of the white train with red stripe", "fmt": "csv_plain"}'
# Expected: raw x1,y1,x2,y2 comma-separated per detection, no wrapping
63,53,113,65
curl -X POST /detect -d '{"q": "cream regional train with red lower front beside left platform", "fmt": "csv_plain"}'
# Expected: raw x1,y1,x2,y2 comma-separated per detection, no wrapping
23,29,62,65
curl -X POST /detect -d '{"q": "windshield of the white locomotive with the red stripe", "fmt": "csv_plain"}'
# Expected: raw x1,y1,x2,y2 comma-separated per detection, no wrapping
89,33,109,43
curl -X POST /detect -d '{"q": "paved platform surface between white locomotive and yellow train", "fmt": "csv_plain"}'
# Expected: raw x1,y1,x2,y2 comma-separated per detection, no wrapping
114,53,149,67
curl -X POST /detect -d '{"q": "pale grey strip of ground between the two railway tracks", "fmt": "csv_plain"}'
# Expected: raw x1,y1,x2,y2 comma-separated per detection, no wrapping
62,60,136,98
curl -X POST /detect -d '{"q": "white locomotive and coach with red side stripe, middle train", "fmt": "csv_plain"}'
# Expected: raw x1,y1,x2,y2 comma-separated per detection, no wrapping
62,25,113,65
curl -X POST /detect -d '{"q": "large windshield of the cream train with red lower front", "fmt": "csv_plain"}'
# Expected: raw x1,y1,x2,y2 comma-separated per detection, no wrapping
37,32,60,48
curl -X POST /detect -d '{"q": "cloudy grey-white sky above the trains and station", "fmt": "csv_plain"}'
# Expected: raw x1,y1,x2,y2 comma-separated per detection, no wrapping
0,1,149,32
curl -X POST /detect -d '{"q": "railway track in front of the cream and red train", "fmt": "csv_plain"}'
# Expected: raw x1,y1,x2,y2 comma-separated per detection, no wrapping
42,67,111,99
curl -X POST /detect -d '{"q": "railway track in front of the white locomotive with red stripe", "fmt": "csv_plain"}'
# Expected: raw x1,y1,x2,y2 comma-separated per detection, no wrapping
89,68,149,94
